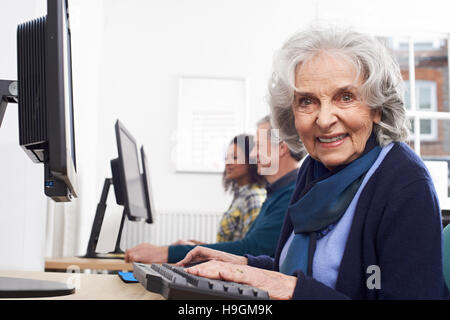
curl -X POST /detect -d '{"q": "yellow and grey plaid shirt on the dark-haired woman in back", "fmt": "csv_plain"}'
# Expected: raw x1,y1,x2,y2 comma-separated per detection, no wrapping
217,185,266,242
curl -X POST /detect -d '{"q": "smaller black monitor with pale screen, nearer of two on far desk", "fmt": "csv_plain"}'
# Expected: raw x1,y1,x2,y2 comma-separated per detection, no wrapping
112,120,147,220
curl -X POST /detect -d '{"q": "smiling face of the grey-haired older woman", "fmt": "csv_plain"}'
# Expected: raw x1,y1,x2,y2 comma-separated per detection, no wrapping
292,53,381,170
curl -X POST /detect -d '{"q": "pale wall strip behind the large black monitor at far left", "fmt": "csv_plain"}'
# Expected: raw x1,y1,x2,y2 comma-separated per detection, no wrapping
0,0,46,270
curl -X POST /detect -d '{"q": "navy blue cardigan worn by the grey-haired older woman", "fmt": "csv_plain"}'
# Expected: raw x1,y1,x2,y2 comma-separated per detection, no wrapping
247,143,450,299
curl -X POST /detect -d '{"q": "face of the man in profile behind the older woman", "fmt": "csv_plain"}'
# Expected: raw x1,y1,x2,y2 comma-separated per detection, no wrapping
250,122,280,175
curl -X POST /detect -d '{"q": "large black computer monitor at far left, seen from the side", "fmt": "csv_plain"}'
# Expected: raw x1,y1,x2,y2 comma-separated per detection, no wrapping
0,0,77,202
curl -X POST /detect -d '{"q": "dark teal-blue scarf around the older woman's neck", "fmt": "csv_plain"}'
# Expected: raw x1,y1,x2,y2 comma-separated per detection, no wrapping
280,138,381,275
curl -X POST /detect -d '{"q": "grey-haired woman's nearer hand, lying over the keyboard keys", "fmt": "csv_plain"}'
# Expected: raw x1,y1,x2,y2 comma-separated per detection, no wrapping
185,261,297,300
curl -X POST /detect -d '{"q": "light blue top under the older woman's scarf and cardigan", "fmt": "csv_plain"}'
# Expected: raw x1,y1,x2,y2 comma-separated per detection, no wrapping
280,143,394,289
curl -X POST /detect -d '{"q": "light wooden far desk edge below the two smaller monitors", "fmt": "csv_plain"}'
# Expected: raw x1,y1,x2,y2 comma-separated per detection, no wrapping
45,257,133,271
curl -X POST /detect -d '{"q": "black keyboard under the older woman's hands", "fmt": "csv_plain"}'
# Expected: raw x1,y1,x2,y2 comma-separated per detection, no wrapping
133,263,269,300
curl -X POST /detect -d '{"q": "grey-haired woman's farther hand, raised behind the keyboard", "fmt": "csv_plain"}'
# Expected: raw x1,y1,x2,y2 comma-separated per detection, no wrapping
176,247,248,267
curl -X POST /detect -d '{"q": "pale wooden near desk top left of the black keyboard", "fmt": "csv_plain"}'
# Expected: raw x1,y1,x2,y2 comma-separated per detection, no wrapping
0,271,164,300
